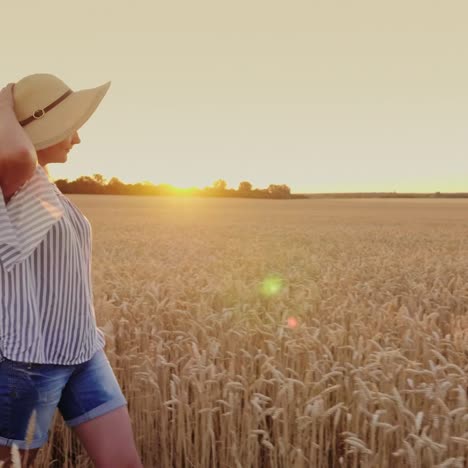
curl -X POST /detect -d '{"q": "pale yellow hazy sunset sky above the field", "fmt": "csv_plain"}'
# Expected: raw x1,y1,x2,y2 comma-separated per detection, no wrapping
0,0,468,193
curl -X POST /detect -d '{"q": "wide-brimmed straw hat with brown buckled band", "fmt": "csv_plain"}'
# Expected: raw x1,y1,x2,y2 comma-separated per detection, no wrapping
13,73,111,150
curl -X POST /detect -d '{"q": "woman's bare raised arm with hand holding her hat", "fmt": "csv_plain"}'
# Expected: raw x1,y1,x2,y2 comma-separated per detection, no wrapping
0,83,37,203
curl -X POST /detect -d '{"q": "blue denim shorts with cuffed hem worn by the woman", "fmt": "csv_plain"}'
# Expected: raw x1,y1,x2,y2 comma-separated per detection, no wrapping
0,349,127,449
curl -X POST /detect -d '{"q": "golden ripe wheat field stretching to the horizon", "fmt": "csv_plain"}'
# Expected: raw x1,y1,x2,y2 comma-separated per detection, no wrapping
23,195,468,468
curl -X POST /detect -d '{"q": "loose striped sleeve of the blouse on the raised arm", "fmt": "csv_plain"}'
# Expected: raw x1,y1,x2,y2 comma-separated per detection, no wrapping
0,164,64,272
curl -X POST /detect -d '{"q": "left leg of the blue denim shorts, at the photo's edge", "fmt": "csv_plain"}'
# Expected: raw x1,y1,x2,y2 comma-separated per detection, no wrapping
0,359,74,449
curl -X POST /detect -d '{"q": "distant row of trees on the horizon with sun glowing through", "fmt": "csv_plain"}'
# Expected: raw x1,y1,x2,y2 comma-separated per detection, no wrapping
55,174,307,199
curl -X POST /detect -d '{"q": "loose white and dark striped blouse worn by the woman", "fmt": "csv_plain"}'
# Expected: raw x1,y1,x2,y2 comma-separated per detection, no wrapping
0,164,105,365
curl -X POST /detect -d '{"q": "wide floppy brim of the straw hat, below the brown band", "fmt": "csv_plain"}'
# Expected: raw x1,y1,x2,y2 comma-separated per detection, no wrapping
23,81,111,151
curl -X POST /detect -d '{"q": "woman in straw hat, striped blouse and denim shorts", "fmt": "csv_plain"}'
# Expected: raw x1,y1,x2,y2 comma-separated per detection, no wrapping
0,74,142,468
